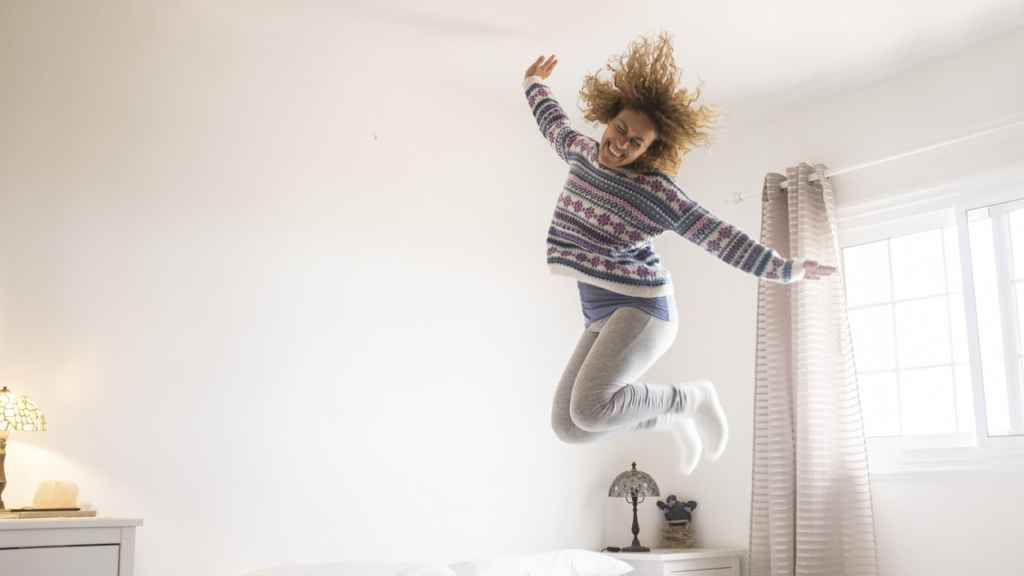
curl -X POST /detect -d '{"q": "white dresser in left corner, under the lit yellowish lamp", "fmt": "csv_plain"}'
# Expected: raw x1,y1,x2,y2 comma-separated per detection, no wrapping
0,518,142,576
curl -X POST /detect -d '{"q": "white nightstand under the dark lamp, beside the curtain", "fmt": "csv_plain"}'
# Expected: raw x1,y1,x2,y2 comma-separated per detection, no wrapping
605,548,746,576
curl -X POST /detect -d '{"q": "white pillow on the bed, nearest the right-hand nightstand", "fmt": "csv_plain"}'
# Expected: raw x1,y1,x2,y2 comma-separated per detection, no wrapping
452,549,633,576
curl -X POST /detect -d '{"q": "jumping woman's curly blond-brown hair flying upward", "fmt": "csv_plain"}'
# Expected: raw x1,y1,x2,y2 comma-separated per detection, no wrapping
580,33,718,174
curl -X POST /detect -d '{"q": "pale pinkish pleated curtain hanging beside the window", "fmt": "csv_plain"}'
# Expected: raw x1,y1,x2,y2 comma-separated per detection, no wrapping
750,164,878,576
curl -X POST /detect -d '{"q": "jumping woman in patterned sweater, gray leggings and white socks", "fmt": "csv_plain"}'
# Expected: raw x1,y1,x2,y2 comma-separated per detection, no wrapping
524,35,835,474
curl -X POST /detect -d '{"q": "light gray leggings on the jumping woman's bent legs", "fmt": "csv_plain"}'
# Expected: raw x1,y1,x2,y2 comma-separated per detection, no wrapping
551,307,684,444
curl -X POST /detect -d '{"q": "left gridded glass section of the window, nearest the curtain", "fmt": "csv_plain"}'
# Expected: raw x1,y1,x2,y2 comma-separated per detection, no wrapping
843,227,970,438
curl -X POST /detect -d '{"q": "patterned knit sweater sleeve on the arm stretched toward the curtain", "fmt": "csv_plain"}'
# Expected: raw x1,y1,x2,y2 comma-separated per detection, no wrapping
665,178,805,284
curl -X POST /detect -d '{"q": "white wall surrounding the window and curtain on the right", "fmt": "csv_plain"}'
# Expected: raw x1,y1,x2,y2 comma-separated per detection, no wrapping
622,24,1024,576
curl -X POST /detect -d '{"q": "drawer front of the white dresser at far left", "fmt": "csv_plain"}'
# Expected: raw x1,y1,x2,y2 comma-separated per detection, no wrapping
0,546,120,576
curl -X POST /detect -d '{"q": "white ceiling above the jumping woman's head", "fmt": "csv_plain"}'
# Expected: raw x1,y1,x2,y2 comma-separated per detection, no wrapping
354,0,1024,104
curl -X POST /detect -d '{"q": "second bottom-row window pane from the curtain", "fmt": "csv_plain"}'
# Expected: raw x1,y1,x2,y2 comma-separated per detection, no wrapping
900,367,956,435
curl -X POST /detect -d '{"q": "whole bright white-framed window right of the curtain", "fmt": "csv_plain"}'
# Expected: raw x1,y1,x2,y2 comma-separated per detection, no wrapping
840,177,1024,463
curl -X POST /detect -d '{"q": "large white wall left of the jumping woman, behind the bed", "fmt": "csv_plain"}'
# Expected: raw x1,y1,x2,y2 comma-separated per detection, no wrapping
0,1,628,576
